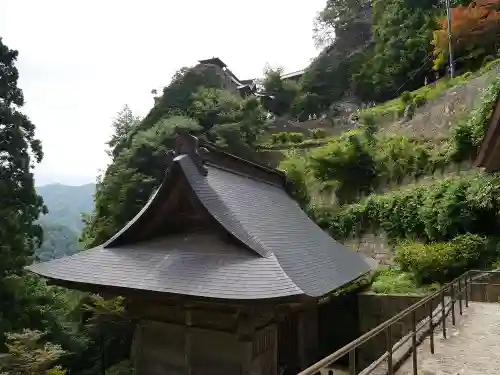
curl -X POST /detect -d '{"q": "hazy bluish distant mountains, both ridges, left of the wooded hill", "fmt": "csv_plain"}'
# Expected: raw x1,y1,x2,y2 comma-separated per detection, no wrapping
36,184,95,261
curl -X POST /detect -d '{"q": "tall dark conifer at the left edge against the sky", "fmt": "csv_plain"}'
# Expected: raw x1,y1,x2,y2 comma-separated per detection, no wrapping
0,39,45,280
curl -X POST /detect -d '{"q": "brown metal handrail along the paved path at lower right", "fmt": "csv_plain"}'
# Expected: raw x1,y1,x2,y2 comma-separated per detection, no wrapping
298,270,499,375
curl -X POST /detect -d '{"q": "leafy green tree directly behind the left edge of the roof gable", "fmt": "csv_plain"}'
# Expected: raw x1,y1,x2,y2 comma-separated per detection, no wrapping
82,116,201,247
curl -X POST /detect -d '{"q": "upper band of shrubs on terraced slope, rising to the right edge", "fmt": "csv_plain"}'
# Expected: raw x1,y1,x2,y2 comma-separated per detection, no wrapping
281,79,500,207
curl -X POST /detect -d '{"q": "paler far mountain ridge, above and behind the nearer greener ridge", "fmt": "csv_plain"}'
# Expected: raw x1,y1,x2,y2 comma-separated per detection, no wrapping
36,184,95,233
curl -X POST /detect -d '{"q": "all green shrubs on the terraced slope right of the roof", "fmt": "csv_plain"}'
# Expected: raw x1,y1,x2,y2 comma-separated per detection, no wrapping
281,79,500,292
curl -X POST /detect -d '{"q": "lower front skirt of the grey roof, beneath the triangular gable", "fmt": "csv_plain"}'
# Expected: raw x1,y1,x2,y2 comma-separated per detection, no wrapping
30,234,303,299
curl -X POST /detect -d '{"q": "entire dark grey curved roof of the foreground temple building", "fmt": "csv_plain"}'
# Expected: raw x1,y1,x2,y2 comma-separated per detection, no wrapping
25,143,373,299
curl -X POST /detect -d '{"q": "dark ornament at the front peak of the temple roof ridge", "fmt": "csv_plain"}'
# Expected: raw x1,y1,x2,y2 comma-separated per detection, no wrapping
167,128,209,176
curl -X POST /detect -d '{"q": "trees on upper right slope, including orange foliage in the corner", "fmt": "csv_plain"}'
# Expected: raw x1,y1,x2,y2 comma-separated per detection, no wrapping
264,0,500,120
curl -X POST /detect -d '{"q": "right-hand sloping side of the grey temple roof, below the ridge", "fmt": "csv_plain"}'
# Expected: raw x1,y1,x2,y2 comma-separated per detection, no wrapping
183,159,370,297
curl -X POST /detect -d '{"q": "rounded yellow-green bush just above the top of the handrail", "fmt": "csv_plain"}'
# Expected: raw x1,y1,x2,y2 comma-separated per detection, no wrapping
396,234,489,283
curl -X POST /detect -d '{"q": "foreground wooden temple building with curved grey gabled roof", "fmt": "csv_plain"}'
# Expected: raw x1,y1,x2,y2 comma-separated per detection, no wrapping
28,132,373,375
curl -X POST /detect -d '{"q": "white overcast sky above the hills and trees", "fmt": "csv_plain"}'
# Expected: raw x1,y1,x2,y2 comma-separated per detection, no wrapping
0,0,326,185
